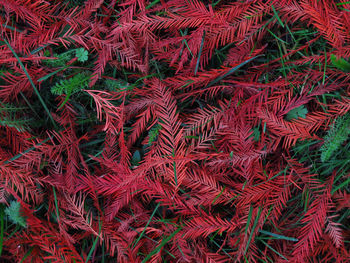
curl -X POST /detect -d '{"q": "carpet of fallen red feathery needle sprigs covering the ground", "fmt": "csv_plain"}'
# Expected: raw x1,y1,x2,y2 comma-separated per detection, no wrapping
0,0,350,262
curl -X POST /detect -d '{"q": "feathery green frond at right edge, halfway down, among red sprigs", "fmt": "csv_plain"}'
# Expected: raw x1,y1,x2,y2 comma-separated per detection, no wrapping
320,114,350,162
